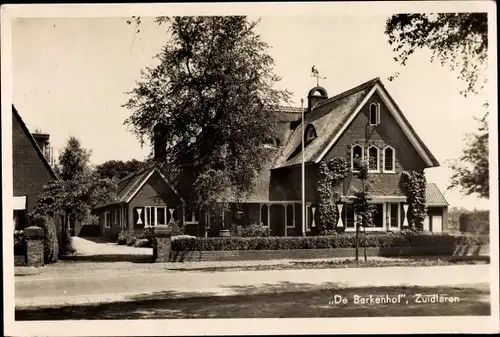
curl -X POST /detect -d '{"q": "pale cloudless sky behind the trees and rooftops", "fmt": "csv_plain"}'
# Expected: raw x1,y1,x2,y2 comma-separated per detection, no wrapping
12,11,489,208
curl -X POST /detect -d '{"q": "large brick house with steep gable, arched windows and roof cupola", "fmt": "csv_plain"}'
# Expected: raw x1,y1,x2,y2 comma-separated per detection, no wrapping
94,78,448,236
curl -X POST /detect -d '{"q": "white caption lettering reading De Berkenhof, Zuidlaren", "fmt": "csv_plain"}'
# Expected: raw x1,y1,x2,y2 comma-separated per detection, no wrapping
328,294,460,305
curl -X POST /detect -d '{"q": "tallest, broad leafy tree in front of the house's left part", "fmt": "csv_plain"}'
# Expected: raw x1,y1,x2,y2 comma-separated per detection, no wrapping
124,16,289,207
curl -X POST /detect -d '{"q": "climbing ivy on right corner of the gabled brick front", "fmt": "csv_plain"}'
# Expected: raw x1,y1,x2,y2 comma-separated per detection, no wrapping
401,171,427,229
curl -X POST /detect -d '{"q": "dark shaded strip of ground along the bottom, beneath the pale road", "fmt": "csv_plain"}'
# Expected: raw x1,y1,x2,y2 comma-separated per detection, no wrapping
15,284,491,320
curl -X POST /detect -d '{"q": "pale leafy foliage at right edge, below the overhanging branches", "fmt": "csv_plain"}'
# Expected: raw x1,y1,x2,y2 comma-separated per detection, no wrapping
448,113,490,198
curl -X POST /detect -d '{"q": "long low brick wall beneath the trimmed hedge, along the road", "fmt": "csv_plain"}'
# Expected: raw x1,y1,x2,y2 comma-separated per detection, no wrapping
170,245,489,262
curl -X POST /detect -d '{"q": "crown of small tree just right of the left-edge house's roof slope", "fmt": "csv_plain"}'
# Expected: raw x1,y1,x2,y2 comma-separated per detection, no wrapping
58,137,91,180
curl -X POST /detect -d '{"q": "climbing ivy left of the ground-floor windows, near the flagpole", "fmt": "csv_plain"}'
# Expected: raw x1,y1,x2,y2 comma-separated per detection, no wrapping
318,158,349,233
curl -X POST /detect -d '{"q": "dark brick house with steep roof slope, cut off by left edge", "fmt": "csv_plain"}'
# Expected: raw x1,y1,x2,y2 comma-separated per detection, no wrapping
12,106,57,228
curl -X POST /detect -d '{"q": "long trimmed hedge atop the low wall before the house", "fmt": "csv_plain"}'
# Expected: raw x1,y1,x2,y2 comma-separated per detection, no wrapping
172,232,489,251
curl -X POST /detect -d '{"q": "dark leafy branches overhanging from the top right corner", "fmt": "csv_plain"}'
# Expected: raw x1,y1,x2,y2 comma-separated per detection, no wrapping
385,13,488,95
